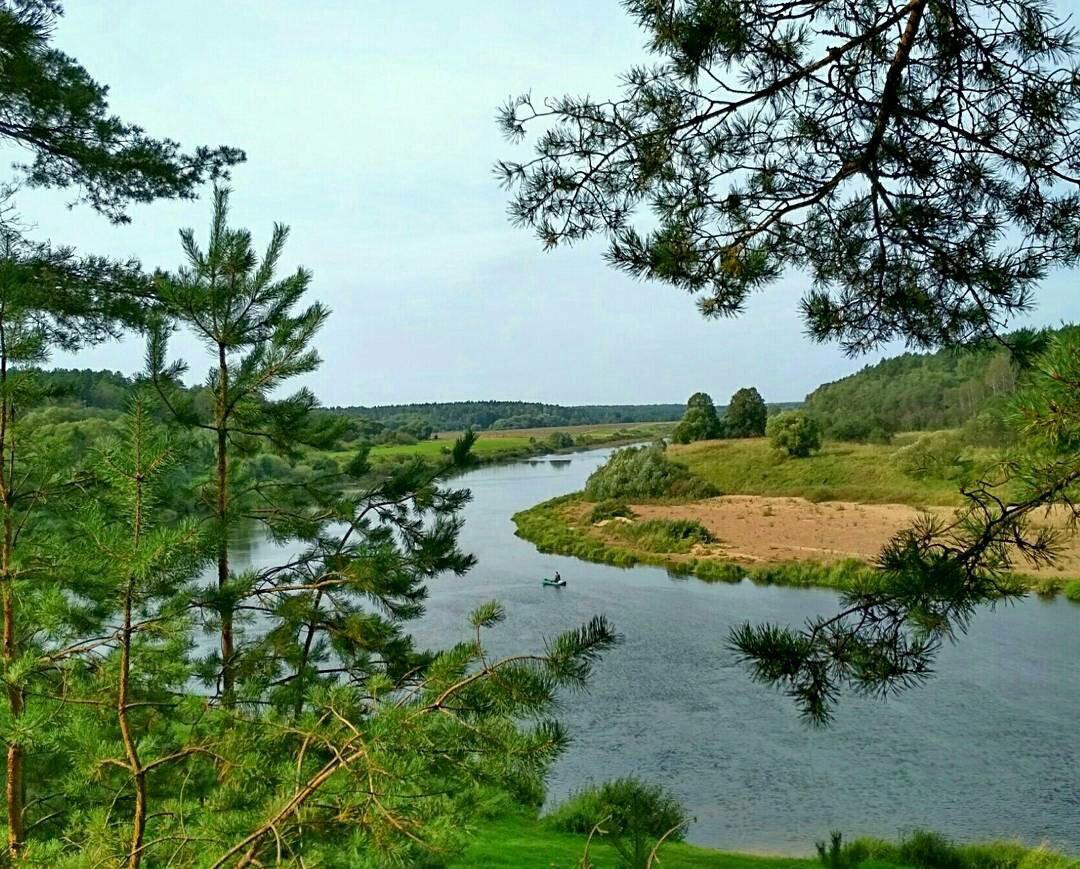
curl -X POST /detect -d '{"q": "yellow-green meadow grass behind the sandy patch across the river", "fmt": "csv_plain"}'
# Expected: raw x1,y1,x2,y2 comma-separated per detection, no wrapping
669,438,993,506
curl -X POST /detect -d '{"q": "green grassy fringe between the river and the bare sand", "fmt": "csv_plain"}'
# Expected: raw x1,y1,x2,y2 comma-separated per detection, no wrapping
513,493,866,588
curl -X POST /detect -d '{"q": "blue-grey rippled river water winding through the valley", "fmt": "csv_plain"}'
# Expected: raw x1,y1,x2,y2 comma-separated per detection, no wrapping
238,450,1080,854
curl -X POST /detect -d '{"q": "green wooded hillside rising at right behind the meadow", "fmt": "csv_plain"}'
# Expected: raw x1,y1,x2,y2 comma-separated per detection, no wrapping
805,326,1080,440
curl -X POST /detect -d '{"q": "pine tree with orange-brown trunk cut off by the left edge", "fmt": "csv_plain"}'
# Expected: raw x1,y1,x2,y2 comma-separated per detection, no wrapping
0,232,146,853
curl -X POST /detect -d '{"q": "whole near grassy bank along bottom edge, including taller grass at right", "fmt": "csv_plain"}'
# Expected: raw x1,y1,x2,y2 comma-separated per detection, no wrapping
449,815,1080,869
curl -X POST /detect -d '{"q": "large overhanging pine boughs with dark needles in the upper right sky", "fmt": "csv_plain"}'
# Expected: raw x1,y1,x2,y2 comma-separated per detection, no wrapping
497,0,1080,352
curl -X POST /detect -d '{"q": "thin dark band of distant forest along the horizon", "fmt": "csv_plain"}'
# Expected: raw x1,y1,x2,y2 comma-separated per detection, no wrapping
333,402,685,432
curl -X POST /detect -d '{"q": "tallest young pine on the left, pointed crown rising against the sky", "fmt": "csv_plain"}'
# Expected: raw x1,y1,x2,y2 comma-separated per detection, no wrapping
147,188,341,706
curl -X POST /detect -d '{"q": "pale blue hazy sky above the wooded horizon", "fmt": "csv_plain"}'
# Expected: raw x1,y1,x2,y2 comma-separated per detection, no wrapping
10,0,1080,405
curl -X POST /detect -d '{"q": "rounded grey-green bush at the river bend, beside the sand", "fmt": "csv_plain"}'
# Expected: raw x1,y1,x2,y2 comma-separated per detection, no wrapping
585,445,716,501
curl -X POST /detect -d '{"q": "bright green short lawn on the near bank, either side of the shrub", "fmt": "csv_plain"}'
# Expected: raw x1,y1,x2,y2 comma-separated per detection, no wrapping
449,816,821,869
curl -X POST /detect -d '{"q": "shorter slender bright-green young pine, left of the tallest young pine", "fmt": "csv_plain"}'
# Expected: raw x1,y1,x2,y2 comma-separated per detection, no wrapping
77,396,205,869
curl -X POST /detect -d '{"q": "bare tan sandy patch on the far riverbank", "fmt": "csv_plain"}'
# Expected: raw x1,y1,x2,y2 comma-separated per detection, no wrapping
632,495,1080,575
